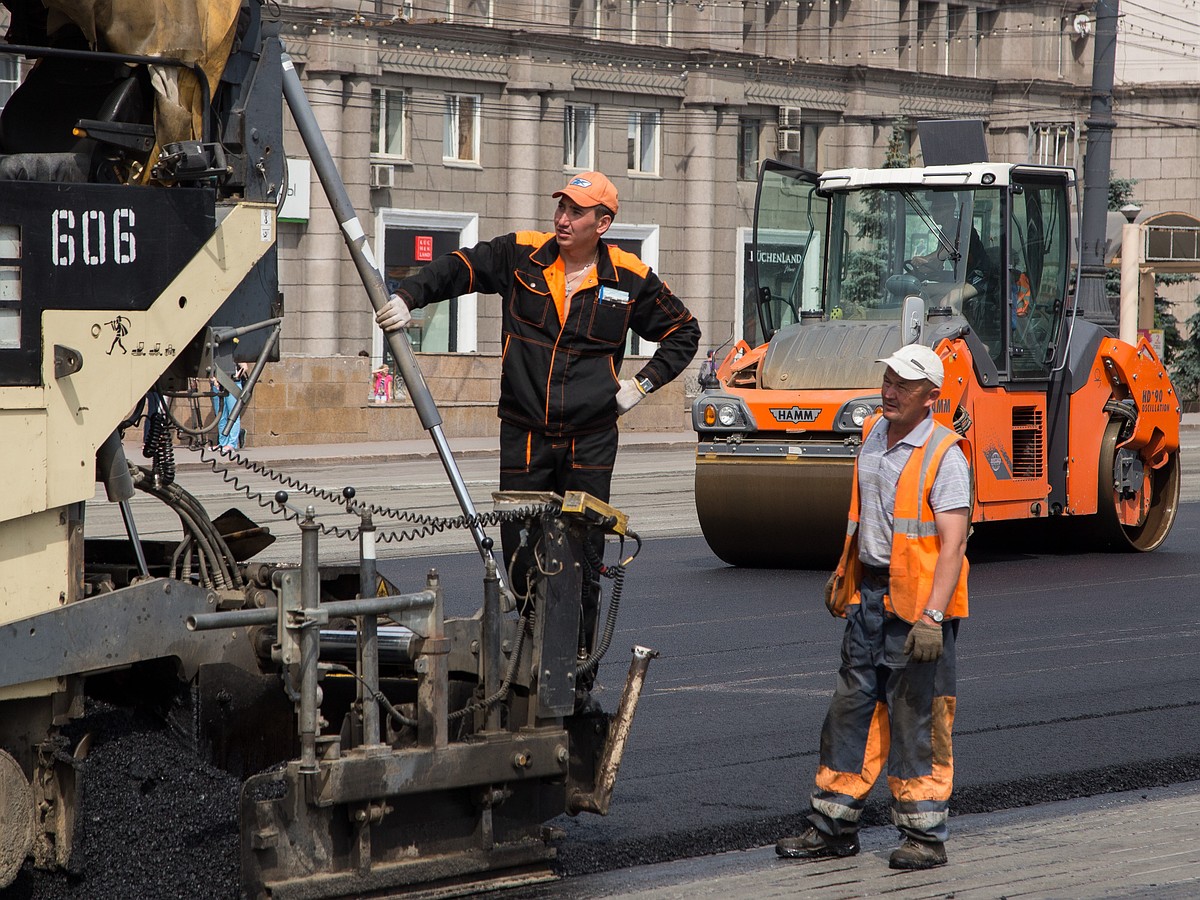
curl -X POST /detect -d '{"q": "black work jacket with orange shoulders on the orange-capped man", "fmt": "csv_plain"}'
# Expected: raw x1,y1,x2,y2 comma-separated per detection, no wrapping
395,232,700,436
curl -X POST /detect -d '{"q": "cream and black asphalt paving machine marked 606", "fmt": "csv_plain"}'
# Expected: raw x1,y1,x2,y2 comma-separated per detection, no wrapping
0,0,655,900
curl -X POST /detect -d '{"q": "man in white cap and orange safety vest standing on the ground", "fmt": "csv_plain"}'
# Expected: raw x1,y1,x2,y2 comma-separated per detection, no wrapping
775,344,971,869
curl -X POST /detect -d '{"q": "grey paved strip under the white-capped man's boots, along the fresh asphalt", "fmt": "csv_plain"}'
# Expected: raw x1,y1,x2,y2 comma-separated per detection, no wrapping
546,782,1200,900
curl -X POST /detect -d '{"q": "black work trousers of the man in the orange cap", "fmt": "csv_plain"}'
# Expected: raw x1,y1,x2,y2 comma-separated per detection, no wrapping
500,420,617,690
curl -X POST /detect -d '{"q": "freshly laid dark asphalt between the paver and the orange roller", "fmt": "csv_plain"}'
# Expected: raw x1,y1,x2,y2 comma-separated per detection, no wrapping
383,504,1200,874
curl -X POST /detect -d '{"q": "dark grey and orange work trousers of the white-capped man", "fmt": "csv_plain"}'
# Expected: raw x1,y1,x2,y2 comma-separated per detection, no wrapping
808,570,958,841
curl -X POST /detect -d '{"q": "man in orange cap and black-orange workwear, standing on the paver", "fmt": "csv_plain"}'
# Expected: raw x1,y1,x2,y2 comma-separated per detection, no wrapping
376,172,700,700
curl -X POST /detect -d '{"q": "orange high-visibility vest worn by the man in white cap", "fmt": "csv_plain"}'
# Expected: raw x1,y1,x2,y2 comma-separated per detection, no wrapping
833,415,971,622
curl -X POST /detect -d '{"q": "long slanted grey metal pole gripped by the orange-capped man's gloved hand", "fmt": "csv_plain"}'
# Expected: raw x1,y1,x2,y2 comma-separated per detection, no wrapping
283,53,503,595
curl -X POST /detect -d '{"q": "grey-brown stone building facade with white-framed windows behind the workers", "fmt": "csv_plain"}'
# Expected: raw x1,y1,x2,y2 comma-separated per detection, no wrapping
0,0,1200,444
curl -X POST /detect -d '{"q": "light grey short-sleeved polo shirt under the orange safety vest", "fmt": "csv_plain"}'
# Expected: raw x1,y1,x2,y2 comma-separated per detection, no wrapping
858,414,971,566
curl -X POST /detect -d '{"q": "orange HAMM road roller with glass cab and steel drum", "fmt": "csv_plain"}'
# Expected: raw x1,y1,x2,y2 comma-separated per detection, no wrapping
692,161,1182,568
